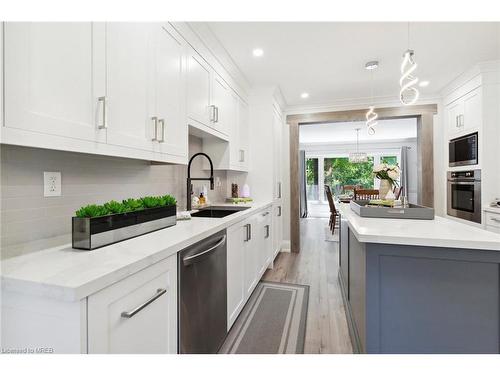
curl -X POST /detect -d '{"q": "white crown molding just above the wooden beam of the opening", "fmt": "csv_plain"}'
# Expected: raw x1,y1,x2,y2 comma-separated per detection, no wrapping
285,95,442,115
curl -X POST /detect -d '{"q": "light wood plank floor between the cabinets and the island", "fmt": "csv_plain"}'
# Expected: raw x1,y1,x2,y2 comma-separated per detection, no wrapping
262,218,352,354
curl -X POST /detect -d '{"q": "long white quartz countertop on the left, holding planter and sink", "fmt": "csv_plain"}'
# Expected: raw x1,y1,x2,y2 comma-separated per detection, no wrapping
1,202,272,301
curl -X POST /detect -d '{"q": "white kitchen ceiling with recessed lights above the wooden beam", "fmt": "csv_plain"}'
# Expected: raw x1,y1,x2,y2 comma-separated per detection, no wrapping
208,22,499,106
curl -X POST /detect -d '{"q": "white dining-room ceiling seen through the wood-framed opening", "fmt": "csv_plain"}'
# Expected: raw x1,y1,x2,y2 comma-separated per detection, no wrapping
299,118,417,144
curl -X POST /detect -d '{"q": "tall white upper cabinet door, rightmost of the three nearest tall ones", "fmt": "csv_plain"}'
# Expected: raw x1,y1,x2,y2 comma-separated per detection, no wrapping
155,26,188,156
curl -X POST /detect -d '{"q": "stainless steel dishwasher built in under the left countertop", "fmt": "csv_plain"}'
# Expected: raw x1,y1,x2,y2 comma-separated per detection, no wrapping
177,230,227,354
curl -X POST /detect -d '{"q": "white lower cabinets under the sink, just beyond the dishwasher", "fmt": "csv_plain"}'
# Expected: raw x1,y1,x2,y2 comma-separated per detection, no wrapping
227,207,272,331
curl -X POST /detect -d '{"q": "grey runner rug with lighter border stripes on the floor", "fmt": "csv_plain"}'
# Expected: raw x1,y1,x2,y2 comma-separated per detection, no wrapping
219,281,309,354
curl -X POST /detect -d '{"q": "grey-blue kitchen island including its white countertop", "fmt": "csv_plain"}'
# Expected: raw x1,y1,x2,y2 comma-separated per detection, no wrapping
339,204,500,353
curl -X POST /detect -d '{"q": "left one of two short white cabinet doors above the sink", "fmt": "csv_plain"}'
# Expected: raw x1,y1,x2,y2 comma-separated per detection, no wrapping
187,49,213,126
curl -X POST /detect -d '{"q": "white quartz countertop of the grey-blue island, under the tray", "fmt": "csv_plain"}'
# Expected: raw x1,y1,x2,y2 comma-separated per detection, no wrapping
336,203,500,251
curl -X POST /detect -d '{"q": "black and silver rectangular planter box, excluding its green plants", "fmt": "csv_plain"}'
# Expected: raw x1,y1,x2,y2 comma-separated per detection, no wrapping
72,205,177,250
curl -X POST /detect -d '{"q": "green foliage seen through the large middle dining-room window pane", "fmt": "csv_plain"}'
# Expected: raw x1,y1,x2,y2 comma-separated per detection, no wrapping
325,157,373,189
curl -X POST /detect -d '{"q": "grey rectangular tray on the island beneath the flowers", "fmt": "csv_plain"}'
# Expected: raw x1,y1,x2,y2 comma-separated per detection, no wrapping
351,200,434,220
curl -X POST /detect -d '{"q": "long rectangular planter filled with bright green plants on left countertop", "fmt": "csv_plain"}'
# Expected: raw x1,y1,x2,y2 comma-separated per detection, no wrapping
72,195,177,250
